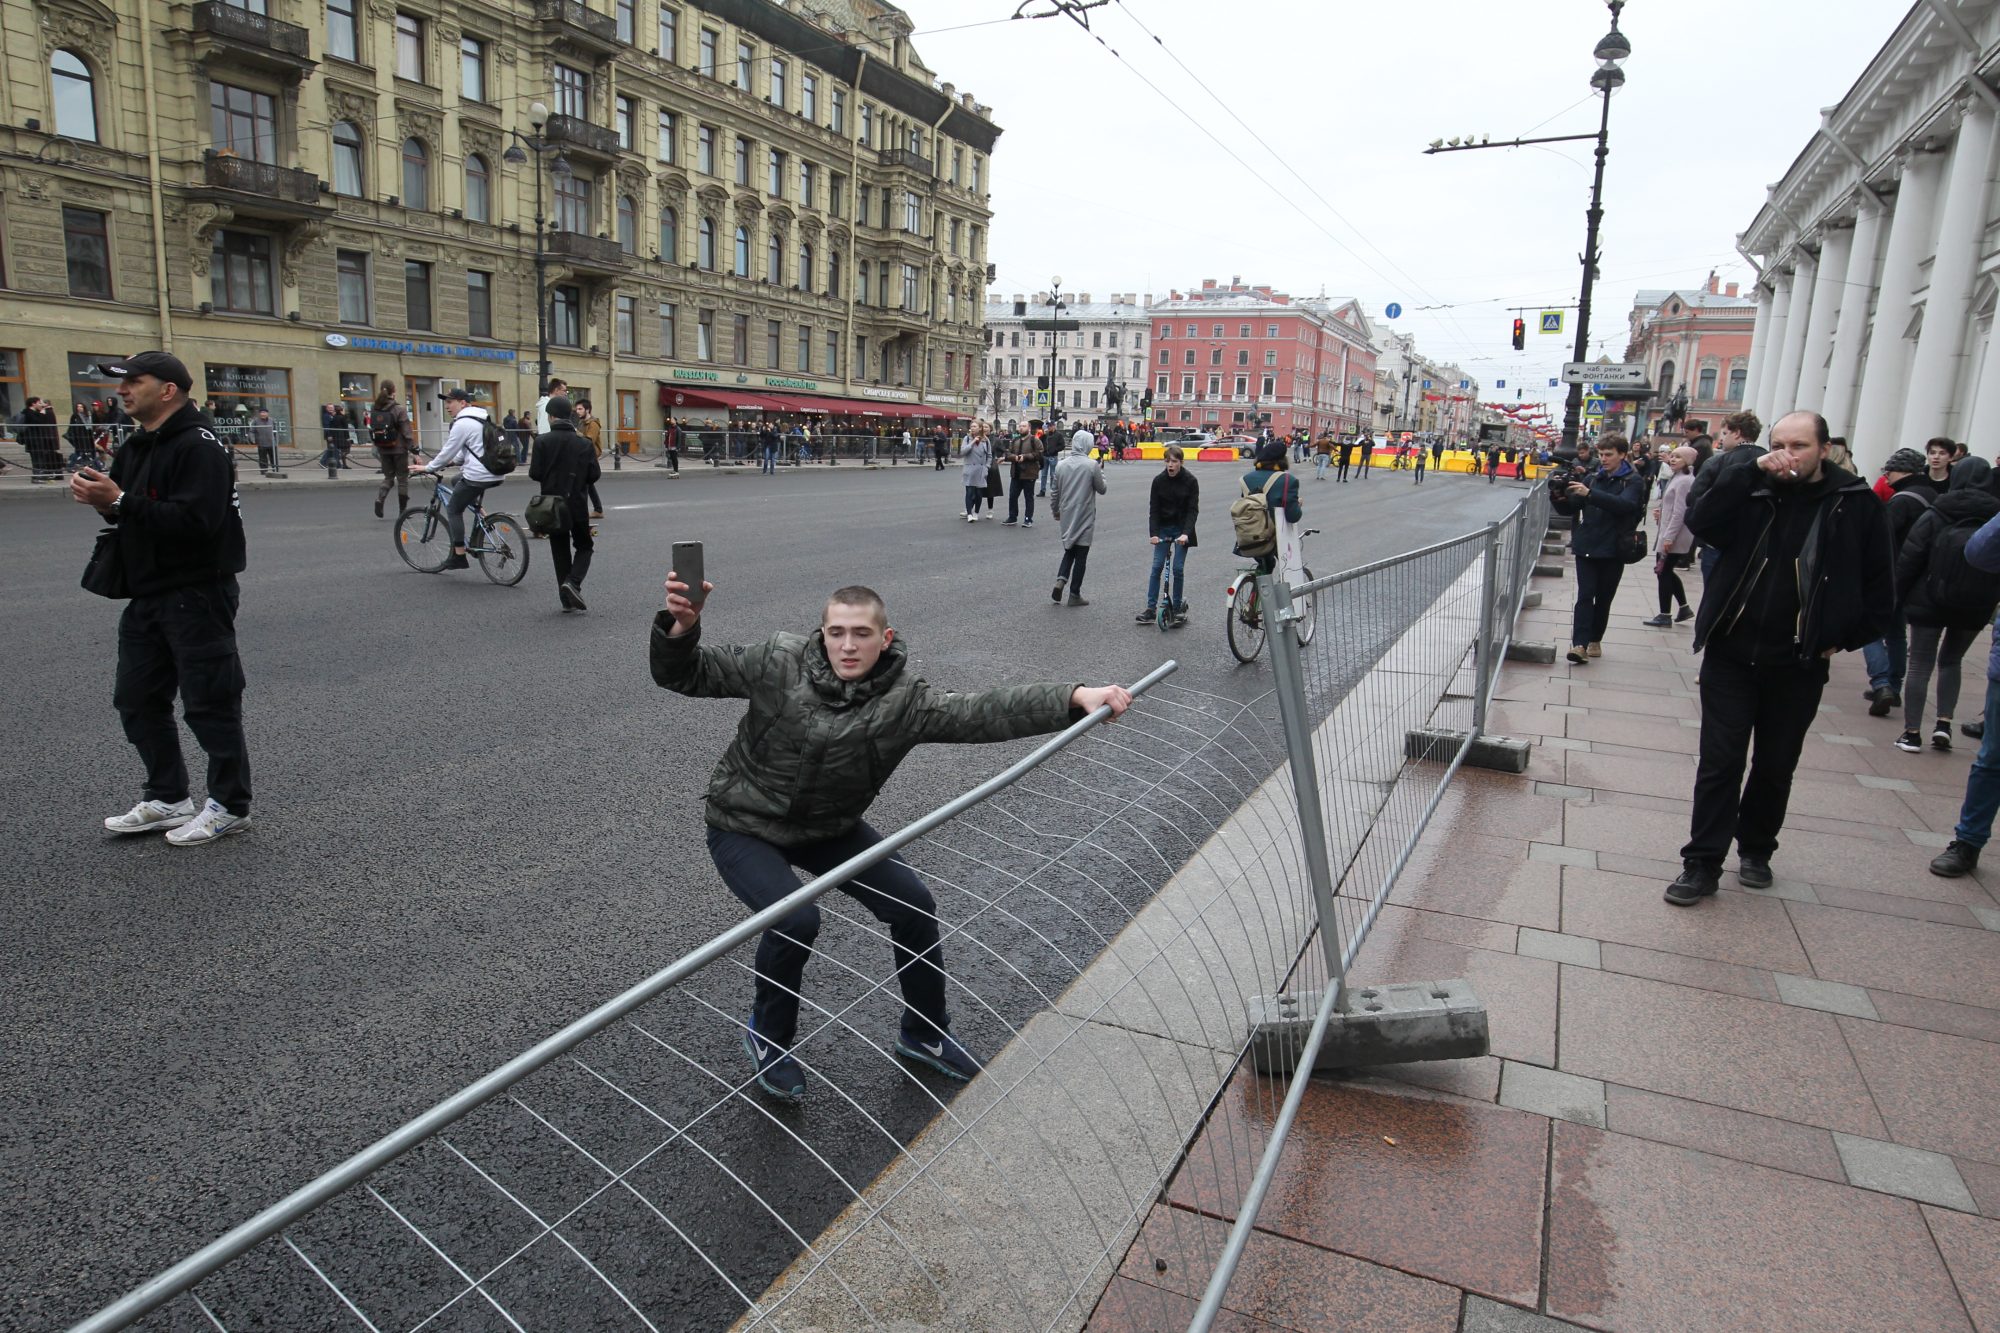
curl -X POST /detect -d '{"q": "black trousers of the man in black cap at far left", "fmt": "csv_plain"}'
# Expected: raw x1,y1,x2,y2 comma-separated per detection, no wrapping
112,576,250,815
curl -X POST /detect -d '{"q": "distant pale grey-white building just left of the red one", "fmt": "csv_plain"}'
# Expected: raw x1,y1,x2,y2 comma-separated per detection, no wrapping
980,292,1152,422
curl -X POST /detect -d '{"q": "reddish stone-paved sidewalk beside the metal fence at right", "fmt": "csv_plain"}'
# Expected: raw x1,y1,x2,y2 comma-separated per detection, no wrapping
1090,544,2000,1333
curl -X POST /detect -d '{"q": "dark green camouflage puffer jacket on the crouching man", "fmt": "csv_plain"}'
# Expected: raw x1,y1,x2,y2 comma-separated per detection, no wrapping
652,610,1082,847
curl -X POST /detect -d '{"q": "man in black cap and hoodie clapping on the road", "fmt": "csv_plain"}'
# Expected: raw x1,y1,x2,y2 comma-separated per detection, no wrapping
70,352,250,847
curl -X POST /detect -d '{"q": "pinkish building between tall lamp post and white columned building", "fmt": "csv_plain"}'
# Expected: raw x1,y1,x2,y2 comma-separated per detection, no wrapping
1624,272,1756,434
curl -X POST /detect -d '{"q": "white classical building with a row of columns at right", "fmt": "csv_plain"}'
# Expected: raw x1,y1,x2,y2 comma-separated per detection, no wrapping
1738,0,2000,472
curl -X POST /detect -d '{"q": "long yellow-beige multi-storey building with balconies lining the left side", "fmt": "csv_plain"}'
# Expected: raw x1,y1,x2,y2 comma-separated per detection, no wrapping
0,0,1000,446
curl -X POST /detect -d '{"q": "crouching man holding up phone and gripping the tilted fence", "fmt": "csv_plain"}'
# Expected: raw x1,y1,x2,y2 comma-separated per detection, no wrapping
652,558,1132,1103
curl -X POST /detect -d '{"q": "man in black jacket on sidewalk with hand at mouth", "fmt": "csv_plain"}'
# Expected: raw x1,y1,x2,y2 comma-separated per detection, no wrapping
1666,412,1896,907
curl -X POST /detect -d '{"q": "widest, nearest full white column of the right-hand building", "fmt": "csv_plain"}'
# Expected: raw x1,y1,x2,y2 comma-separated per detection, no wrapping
1896,102,1994,444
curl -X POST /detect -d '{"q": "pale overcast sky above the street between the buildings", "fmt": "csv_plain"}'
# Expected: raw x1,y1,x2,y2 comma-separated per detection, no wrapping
898,0,1906,410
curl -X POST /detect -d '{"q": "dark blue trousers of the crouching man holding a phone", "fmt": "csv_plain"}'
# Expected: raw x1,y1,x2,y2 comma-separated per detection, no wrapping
708,823,950,1047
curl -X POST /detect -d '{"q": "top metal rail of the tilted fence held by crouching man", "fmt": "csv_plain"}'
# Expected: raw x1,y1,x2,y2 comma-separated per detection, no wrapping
72,660,1178,1333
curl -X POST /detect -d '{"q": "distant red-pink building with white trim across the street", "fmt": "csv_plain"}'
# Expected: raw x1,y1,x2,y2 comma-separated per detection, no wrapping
1148,278,1376,434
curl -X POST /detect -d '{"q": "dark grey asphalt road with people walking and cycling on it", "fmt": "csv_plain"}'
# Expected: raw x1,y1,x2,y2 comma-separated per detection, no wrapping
0,452,1518,1329
